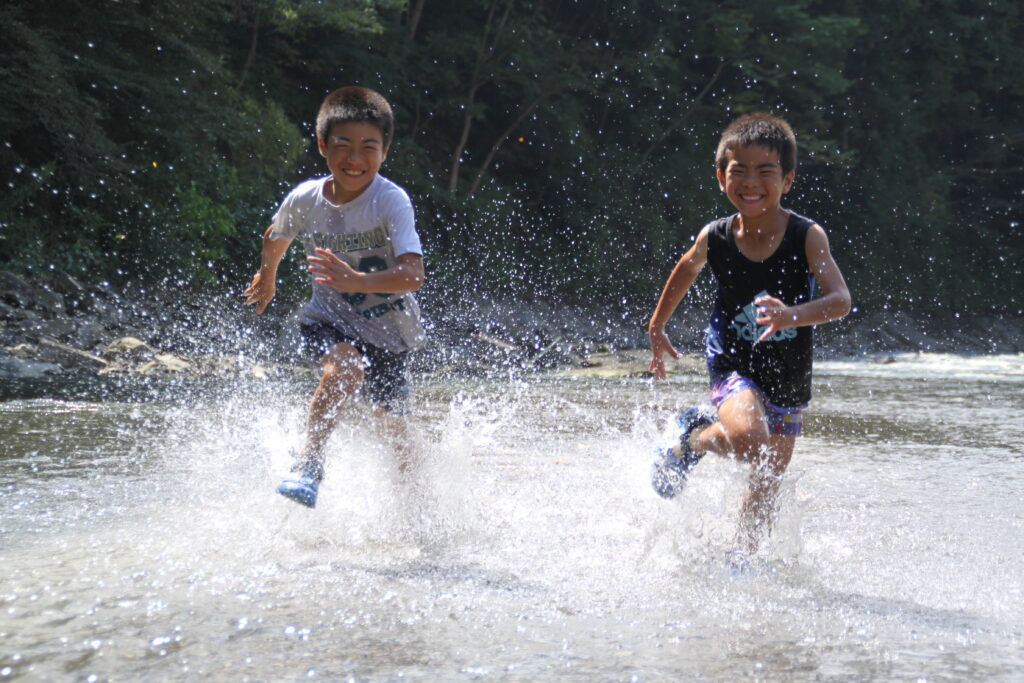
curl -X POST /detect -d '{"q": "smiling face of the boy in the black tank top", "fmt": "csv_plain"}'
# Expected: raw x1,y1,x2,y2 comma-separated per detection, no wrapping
718,144,796,218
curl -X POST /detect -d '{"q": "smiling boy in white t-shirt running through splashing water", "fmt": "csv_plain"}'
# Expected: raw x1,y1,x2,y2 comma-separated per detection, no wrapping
244,86,424,508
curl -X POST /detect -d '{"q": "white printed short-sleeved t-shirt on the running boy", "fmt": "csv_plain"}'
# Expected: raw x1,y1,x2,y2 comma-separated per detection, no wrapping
270,174,426,353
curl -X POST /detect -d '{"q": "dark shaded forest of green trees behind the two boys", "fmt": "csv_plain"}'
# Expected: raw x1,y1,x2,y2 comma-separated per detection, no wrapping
0,0,1024,313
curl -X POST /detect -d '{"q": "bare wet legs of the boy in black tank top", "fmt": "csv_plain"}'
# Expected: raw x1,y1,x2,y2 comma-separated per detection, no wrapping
690,390,797,552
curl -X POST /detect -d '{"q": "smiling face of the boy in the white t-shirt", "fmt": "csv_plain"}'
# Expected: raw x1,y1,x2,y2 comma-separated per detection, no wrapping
316,121,387,204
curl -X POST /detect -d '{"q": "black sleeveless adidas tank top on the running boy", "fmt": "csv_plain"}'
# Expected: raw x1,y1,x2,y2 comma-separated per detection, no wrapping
706,212,814,408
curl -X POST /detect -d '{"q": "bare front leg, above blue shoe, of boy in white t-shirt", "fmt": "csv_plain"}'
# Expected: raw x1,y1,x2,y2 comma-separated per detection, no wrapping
301,343,364,471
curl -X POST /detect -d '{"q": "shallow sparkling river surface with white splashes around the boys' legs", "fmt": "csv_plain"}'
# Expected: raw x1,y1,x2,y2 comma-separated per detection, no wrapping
0,354,1024,681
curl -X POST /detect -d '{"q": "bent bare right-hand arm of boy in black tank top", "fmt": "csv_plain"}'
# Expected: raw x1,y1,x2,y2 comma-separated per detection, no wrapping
755,224,852,340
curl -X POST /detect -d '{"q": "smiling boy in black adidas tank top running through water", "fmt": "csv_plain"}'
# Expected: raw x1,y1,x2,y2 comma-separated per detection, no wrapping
648,114,850,552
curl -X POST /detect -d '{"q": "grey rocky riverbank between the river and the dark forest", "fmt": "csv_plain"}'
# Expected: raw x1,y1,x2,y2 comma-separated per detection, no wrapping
0,271,1024,379
